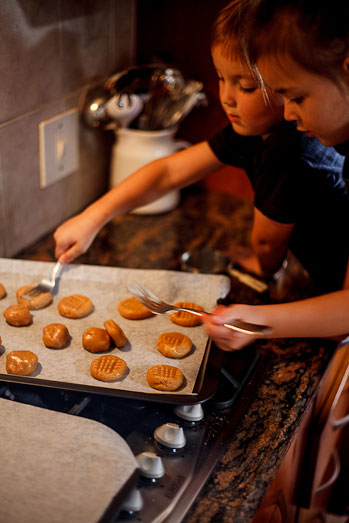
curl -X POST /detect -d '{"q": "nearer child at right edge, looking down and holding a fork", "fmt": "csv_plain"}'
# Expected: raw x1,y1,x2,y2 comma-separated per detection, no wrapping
206,0,349,350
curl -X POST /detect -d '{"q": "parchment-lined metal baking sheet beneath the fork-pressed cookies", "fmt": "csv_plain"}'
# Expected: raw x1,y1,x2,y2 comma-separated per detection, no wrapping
0,259,230,401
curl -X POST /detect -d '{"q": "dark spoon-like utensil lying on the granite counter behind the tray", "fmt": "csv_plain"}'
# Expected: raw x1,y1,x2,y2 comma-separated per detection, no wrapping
181,247,268,293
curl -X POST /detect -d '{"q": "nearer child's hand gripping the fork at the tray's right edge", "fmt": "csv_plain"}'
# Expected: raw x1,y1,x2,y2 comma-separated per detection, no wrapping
203,305,257,351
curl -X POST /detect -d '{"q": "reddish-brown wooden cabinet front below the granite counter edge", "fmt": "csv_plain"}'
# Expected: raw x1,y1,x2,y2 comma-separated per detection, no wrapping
253,345,349,523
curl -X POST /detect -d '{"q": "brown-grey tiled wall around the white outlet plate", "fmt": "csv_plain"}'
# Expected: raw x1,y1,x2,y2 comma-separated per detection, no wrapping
0,0,136,257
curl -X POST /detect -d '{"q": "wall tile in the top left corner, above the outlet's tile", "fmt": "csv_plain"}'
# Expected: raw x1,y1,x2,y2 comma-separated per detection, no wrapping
0,0,60,122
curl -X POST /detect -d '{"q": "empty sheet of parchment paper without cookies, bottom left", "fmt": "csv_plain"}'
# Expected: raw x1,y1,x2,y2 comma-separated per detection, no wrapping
0,399,138,523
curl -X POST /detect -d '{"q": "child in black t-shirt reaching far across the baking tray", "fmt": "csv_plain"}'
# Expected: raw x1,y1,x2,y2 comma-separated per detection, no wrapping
54,0,349,330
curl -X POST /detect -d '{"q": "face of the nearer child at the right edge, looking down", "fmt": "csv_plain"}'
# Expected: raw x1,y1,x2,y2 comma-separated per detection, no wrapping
258,58,349,146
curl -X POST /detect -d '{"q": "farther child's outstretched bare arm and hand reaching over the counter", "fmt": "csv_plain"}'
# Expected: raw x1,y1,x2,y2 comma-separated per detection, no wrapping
54,142,223,263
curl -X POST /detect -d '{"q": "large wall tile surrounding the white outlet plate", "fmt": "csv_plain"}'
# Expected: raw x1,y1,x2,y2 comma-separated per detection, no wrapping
0,97,108,257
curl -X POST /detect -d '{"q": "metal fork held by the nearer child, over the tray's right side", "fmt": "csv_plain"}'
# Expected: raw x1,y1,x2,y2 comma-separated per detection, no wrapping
128,282,272,336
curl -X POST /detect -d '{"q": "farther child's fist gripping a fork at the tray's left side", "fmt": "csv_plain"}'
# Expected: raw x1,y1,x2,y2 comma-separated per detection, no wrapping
53,213,99,263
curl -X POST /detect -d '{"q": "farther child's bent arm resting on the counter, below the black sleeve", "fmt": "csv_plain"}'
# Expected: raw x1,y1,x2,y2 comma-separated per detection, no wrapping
237,208,294,277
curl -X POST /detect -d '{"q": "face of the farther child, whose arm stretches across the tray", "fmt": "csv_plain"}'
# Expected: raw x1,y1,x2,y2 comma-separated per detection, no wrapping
212,45,283,136
